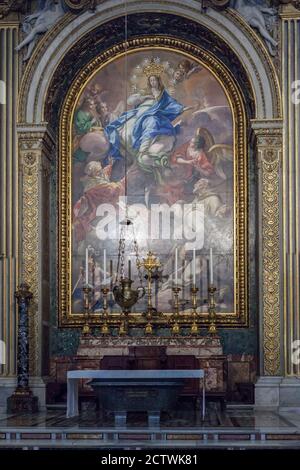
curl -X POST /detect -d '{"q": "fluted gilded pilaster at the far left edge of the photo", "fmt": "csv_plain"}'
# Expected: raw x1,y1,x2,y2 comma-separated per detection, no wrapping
0,21,20,409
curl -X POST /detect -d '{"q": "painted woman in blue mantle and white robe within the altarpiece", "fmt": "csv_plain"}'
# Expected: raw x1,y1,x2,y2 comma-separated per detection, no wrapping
104,70,187,180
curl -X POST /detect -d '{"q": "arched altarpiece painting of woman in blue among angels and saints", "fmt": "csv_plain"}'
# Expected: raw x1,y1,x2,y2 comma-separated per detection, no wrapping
59,47,246,325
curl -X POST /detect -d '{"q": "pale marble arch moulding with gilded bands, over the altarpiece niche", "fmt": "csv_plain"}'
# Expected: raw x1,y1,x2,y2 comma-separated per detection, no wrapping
18,0,281,124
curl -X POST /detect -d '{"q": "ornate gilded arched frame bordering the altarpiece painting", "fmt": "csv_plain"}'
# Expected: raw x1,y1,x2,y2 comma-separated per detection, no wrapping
58,36,248,327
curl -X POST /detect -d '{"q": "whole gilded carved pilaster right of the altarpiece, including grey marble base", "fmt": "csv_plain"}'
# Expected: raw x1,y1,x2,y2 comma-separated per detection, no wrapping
252,120,283,407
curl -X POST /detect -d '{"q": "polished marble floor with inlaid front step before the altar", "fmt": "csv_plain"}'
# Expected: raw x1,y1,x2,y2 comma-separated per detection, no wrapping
0,407,300,449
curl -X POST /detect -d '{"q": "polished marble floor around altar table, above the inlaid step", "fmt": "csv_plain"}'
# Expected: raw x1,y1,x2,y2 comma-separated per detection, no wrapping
0,407,300,432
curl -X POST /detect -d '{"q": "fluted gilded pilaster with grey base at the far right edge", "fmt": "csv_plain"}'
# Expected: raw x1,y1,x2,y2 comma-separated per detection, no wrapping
280,5,300,408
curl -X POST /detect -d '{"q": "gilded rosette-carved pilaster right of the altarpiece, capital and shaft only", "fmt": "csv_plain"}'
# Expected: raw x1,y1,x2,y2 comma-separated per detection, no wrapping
255,122,282,375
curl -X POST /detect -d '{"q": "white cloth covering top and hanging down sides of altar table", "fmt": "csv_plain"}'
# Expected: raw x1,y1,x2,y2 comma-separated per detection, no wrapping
67,369,205,419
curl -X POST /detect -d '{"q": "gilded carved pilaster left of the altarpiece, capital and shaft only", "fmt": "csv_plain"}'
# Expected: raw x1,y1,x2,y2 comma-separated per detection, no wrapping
19,128,53,376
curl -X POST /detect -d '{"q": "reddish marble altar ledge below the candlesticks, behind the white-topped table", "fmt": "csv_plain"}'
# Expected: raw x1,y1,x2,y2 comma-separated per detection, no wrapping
74,336,227,393
